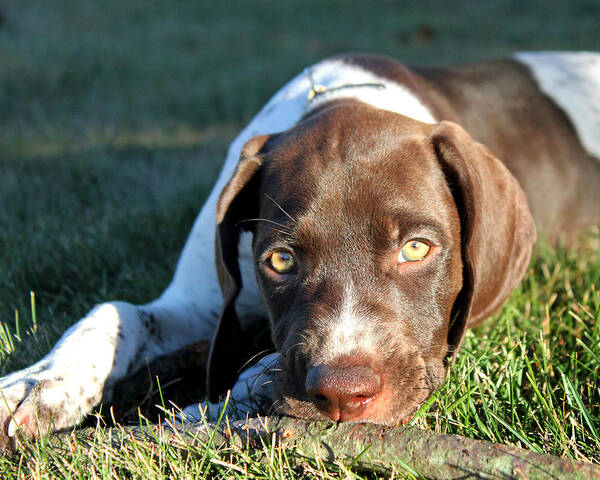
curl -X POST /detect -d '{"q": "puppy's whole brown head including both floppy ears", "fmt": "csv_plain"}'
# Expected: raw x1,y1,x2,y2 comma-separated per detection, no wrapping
209,101,535,424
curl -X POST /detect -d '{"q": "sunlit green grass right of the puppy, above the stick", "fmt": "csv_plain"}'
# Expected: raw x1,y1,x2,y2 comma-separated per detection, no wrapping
417,231,600,463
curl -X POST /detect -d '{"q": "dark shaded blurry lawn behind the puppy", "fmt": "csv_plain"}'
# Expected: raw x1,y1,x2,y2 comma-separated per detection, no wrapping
0,0,600,373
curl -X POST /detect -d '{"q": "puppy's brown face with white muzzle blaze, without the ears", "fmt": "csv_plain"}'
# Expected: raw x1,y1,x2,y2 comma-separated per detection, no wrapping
248,108,462,423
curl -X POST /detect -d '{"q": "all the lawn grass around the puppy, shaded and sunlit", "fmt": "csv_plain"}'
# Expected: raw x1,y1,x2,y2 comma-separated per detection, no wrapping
0,0,600,479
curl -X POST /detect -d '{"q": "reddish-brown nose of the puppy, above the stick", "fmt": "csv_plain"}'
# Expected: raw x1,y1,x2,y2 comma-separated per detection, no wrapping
305,365,381,421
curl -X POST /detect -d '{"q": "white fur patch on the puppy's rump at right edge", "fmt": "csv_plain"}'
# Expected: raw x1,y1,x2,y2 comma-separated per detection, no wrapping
515,52,600,159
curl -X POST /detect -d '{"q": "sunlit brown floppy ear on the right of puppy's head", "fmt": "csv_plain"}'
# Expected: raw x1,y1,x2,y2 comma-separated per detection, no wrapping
433,122,536,356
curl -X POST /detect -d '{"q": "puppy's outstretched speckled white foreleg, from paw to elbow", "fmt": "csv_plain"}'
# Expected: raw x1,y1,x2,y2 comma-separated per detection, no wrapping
0,296,220,448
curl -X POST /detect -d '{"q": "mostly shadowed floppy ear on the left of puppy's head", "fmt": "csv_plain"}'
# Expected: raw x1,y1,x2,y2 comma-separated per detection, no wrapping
206,135,269,402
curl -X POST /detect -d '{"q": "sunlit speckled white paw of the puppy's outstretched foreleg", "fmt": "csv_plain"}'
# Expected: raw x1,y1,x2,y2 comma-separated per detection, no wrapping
0,372,99,451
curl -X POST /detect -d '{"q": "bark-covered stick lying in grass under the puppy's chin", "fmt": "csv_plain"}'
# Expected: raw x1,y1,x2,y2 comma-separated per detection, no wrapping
51,417,600,480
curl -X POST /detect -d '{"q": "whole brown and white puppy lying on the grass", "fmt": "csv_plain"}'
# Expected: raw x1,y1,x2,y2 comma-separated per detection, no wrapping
0,53,600,445
